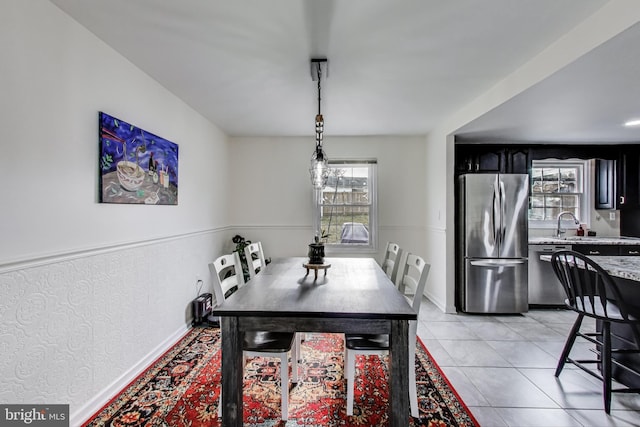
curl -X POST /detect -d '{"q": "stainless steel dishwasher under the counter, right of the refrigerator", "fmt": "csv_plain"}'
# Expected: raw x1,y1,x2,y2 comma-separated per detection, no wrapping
529,245,571,306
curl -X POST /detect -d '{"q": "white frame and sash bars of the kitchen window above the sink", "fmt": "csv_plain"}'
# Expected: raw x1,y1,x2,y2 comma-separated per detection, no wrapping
527,159,593,229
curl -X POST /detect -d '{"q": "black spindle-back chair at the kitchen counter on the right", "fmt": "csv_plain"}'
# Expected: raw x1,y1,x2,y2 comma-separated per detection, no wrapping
551,250,640,414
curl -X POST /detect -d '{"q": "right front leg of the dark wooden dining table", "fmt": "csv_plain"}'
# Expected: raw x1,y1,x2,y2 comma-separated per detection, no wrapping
389,320,409,427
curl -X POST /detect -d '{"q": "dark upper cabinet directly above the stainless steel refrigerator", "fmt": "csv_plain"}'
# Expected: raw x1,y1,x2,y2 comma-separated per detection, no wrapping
456,144,530,174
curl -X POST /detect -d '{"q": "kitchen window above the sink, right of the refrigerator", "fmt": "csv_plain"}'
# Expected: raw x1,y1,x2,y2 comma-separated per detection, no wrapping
529,160,589,228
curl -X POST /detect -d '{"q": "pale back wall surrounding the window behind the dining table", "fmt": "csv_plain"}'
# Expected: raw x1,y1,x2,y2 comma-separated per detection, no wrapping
230,137,428,259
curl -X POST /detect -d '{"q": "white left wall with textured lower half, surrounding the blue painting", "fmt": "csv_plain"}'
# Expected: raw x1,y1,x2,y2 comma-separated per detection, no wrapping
0,0,229,425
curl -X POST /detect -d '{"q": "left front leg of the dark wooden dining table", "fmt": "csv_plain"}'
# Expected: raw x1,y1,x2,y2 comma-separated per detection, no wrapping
221,316,243,427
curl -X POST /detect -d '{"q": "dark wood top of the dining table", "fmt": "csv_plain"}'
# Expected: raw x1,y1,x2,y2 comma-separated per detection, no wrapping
213,257,417,320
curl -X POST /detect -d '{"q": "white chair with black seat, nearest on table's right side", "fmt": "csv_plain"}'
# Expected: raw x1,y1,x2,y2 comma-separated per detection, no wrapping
345,252,431,417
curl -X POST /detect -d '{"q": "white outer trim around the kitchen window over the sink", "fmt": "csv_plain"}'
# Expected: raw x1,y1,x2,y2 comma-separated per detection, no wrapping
529,159,593,229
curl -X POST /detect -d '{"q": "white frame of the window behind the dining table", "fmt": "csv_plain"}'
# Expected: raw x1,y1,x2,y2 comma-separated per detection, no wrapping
312,158,378,255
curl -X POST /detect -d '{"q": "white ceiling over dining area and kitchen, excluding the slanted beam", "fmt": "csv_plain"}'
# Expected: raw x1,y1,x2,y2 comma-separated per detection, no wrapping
51,0,640,142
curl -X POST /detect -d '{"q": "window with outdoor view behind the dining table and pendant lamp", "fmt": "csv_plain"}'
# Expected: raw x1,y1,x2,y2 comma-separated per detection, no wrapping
314,160,377,251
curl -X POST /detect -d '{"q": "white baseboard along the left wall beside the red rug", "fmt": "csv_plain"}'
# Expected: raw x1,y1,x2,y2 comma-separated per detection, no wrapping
69,324,191,427
